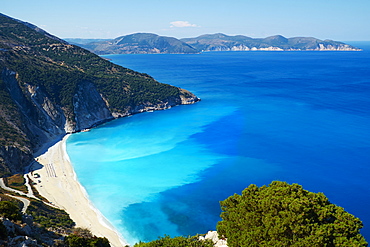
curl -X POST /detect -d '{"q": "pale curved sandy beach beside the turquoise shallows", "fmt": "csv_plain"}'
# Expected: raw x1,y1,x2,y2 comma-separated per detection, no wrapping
30,135,127,247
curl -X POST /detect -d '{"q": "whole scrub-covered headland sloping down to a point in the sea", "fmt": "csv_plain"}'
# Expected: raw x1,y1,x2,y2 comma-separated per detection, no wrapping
0,15,199,175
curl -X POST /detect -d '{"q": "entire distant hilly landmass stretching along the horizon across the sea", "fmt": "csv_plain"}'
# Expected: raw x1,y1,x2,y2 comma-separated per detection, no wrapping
66,33,361,55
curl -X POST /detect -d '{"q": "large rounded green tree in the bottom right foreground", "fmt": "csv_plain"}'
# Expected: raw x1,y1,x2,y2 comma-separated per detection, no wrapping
217,181,367,247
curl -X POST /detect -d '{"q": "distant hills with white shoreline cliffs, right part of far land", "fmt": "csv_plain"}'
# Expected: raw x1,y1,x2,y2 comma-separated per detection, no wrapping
181,33,360,51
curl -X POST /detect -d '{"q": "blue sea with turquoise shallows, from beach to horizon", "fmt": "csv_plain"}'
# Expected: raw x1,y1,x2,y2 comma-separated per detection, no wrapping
67,43,370,244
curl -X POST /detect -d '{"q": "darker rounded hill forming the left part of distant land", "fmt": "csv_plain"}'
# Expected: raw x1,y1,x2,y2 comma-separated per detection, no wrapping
80,33,198,55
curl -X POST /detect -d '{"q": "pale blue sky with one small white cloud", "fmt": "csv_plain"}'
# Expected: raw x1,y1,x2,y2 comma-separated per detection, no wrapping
0,0,370,41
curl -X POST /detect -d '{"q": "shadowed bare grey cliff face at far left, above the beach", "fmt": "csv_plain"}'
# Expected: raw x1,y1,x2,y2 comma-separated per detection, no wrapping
0,68,66,174
